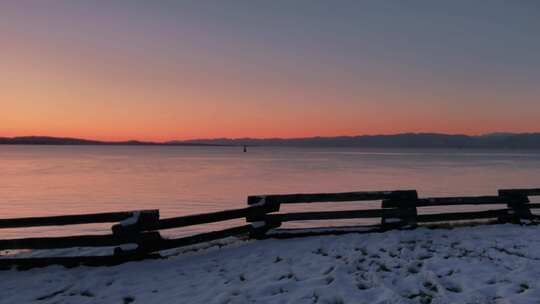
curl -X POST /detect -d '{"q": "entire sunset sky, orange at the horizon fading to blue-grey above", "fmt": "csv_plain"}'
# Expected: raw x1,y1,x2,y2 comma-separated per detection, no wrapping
0,0,540,141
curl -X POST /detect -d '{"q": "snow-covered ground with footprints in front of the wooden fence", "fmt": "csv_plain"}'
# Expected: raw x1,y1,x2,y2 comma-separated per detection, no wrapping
0,224,540,304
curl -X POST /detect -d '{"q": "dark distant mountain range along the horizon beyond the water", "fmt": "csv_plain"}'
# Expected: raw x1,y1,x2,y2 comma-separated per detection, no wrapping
0,133,540,149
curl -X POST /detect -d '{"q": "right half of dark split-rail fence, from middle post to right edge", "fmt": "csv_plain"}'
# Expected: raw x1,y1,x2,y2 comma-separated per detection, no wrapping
247,189,540,238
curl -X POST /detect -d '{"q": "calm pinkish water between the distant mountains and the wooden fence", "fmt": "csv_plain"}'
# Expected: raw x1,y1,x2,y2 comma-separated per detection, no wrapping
0,146,540,236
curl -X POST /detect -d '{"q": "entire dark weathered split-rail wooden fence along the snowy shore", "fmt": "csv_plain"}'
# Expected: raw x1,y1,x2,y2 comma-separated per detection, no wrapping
0,189,540,269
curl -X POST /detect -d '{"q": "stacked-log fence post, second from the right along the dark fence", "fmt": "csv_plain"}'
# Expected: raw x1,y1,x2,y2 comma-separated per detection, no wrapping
381,190,418,230
